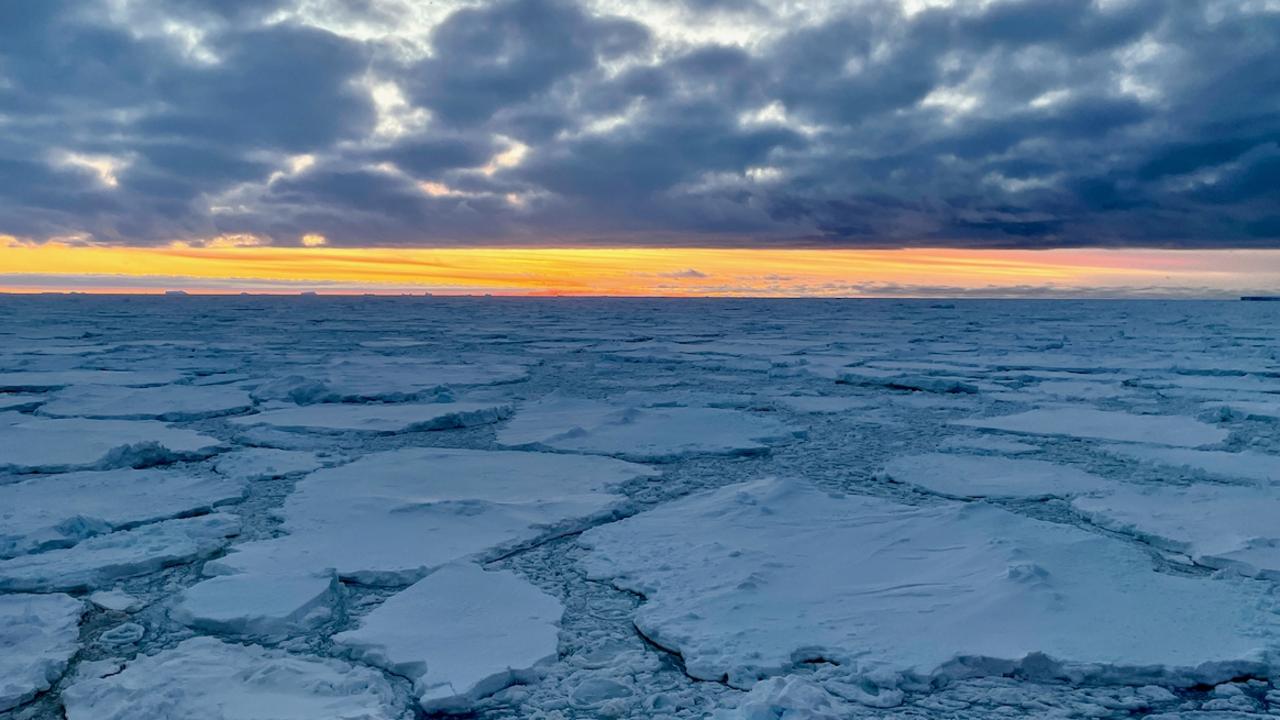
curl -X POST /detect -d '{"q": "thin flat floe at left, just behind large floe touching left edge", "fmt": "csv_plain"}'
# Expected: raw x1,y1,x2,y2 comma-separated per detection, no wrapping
38,386,253,421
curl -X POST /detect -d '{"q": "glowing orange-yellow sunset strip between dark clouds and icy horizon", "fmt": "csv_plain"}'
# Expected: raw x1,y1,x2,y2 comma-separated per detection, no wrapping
0,242,1280,297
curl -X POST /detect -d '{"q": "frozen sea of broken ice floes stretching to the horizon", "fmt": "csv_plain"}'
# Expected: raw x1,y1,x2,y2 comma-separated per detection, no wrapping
0,296,1280,720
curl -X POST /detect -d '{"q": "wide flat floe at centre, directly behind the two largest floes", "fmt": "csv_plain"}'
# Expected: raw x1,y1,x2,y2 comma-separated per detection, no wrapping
498,397,801,462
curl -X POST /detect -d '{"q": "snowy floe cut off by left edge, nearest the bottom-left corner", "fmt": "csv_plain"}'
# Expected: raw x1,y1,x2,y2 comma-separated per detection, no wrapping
0,594,84,712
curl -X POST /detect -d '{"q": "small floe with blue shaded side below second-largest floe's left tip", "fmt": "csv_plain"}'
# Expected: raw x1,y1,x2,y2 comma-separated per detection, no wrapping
170,570,342,635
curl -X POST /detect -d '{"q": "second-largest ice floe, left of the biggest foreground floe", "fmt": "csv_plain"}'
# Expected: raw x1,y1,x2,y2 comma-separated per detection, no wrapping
210,448,653,584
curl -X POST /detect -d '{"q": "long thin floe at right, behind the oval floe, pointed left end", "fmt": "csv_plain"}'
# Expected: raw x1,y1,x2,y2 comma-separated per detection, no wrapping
954,407,1229,447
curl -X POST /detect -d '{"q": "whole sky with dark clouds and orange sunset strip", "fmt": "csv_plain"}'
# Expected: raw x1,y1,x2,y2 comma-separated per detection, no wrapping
0,0,1280,297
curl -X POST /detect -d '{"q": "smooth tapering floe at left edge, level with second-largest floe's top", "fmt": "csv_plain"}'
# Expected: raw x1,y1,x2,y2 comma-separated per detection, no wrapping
0,469,244,559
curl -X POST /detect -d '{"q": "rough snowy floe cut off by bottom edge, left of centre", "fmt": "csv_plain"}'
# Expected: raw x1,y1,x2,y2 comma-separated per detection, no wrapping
63,638,411,720
